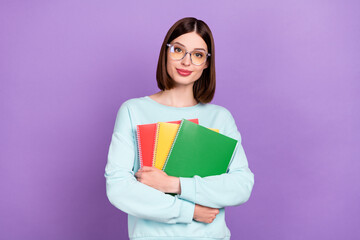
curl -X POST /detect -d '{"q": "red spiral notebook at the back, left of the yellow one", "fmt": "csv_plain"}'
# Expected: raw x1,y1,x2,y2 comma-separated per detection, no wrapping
136,118,199,167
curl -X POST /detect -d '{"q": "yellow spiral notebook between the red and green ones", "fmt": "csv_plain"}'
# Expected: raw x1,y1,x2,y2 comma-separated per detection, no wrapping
153,122,219,170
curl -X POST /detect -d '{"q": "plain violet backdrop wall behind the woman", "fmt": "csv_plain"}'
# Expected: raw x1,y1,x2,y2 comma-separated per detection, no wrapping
0,0,360,240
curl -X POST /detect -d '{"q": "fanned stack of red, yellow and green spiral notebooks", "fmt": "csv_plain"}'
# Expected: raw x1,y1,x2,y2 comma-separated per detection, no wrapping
137,118,238,184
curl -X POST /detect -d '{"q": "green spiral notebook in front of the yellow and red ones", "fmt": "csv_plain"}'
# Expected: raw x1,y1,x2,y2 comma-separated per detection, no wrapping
163,118,238,177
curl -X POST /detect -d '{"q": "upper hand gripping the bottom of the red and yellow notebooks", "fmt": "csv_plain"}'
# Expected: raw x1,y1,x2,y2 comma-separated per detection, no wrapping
135,166,180,193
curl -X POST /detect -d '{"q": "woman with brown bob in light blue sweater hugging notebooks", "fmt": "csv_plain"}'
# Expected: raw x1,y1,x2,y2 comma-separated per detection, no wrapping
105,18,254,240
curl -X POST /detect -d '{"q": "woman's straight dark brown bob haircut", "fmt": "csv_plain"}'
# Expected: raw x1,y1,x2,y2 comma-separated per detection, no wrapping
156,17,216,103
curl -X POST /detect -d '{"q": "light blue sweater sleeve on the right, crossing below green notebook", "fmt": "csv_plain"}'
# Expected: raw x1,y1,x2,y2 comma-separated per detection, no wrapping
179,110,254,208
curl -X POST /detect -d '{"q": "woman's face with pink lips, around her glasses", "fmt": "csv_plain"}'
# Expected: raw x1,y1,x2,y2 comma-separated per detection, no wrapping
166,32,209,86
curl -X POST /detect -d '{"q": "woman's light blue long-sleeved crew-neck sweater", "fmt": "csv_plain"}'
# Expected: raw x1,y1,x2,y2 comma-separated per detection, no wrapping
105,96,254,240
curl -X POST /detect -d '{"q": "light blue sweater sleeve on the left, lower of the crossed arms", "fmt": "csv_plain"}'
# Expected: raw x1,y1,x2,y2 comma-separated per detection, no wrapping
104,101,195,224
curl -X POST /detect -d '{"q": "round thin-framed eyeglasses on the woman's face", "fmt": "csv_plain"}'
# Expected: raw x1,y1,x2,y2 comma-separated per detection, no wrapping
166,43,211,65
